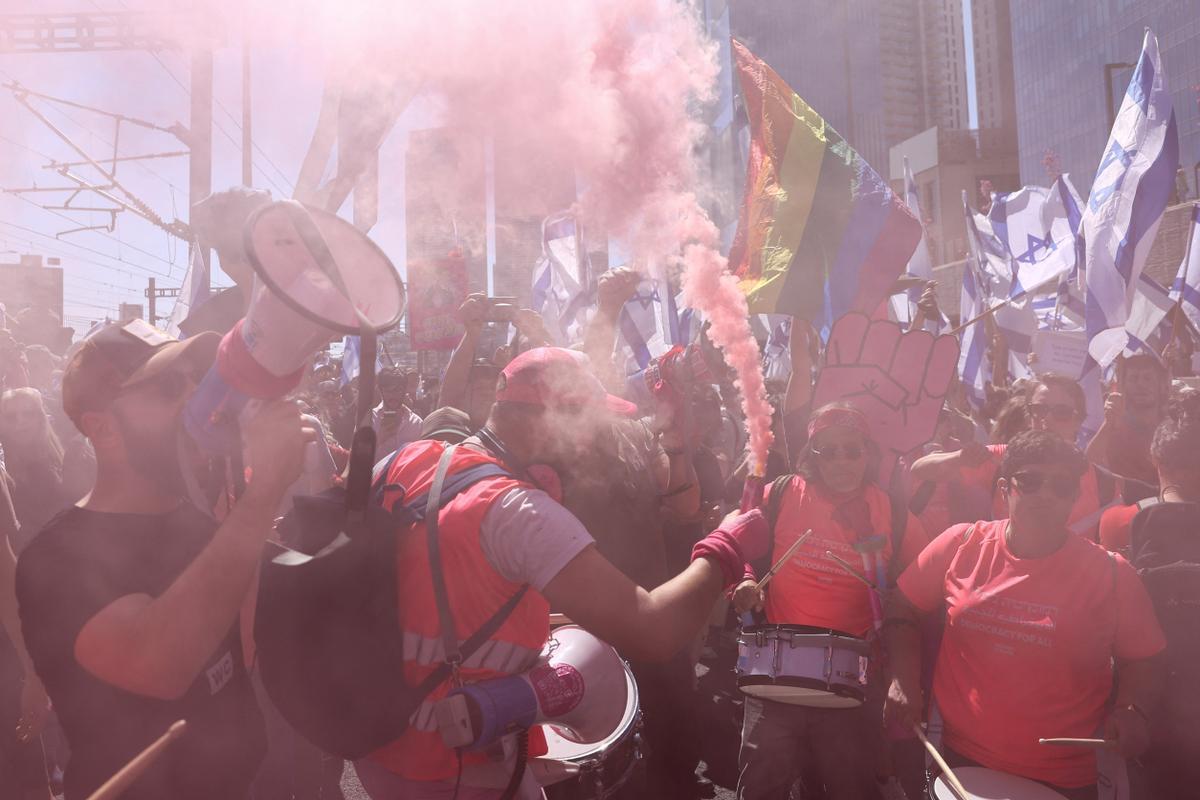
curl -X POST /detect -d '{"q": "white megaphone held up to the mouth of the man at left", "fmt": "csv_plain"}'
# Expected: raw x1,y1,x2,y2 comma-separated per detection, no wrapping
184,200,404,455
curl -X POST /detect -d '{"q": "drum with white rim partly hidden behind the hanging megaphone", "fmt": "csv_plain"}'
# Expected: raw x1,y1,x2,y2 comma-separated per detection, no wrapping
529,626,642,800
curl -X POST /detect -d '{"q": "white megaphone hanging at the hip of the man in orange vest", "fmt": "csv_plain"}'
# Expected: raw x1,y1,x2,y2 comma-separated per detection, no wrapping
434,625,629,750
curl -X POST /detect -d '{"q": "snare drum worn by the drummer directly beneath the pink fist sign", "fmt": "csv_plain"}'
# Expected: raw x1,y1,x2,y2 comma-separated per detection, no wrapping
737,625,870,709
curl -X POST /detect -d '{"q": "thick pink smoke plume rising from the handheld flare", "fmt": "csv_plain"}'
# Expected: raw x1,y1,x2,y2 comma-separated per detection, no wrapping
174,0,770,469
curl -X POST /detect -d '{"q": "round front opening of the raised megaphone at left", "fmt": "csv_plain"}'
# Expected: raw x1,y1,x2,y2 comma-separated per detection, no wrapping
242,200,404,335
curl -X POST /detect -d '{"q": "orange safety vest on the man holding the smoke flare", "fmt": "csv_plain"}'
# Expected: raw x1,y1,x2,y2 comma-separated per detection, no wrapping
368,441,550,781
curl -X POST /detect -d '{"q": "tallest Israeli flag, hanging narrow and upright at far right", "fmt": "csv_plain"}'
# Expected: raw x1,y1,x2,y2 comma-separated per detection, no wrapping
1082,29,1180,367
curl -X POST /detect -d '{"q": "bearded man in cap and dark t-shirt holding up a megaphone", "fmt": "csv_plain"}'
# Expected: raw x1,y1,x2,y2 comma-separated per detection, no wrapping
17,320,314,800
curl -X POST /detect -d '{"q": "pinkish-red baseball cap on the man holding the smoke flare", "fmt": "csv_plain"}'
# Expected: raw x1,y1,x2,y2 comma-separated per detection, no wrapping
496,348,637,416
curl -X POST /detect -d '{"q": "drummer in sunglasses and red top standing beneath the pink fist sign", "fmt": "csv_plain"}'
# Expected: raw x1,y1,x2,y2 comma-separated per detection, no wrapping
733,403,928,800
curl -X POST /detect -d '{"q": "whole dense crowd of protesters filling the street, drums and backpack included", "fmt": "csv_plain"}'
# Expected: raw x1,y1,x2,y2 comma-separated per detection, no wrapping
0,215,1200,800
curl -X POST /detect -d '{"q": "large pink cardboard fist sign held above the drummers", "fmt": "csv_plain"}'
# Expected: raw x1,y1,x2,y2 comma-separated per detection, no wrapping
812,313,959,485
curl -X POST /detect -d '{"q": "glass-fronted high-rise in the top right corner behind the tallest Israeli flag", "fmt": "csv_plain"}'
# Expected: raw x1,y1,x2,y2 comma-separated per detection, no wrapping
1012,0,1200,197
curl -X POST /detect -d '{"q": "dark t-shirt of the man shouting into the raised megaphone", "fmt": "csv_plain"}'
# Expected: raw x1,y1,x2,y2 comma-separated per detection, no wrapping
17,505,265,800
